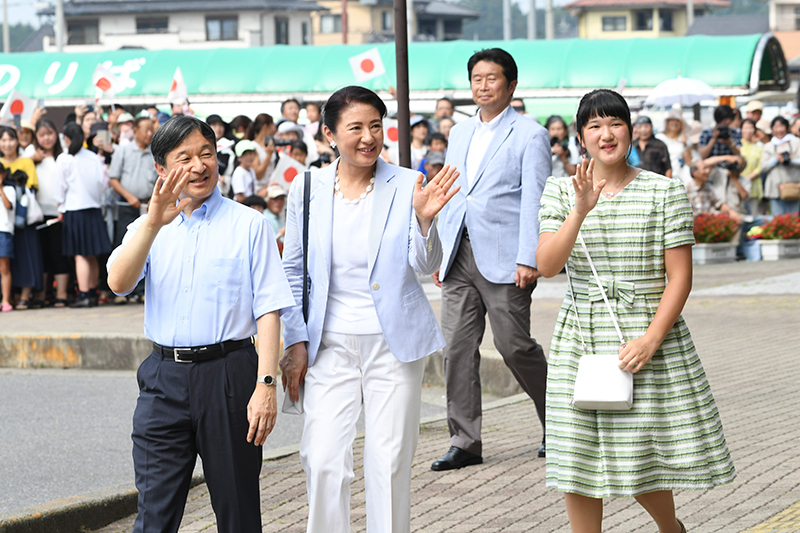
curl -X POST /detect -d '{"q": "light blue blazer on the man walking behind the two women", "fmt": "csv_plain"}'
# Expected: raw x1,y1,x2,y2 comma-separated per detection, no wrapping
439,108,552,283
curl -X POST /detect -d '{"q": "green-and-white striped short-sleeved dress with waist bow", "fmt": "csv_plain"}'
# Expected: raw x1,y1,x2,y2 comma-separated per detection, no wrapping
539,171,736,498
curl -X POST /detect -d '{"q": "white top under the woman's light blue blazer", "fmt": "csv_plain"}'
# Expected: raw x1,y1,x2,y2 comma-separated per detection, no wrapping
322,194,383,335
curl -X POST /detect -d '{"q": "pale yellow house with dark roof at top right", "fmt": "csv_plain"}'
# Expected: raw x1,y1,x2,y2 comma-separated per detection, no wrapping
564,0,728,39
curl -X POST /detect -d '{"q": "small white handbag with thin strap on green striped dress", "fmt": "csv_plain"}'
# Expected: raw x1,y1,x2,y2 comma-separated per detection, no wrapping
567,232,633,411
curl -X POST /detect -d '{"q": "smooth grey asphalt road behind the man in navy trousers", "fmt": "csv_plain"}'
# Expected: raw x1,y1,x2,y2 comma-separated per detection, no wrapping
0,369,478,514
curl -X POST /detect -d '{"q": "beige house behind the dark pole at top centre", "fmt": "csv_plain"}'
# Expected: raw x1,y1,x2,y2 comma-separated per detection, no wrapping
312,0,480,44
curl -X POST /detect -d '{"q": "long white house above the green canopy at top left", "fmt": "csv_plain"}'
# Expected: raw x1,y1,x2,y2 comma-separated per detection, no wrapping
33,0,324,52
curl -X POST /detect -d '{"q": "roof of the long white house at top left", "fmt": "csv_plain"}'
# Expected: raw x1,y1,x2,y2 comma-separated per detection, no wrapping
37,0,325,17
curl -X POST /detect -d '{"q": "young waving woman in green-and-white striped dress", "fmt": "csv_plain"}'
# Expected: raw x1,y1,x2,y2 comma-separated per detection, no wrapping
536,90,736,533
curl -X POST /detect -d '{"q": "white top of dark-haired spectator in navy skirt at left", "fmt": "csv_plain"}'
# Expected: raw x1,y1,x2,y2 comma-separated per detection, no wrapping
53,148,105,213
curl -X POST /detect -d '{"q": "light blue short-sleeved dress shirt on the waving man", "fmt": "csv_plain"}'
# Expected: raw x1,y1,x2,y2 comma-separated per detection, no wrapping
108,189,295,347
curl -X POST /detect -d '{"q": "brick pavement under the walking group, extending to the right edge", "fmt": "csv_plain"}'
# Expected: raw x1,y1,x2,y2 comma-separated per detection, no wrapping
92,261,800,533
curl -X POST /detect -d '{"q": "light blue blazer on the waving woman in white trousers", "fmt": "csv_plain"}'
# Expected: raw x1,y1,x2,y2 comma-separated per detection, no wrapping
281,159,444,366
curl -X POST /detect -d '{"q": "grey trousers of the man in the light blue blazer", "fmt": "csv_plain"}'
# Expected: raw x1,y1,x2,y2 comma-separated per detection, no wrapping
442,238,547,455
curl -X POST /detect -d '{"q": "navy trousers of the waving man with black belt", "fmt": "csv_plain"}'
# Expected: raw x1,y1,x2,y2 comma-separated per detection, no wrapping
132,345,261,533
